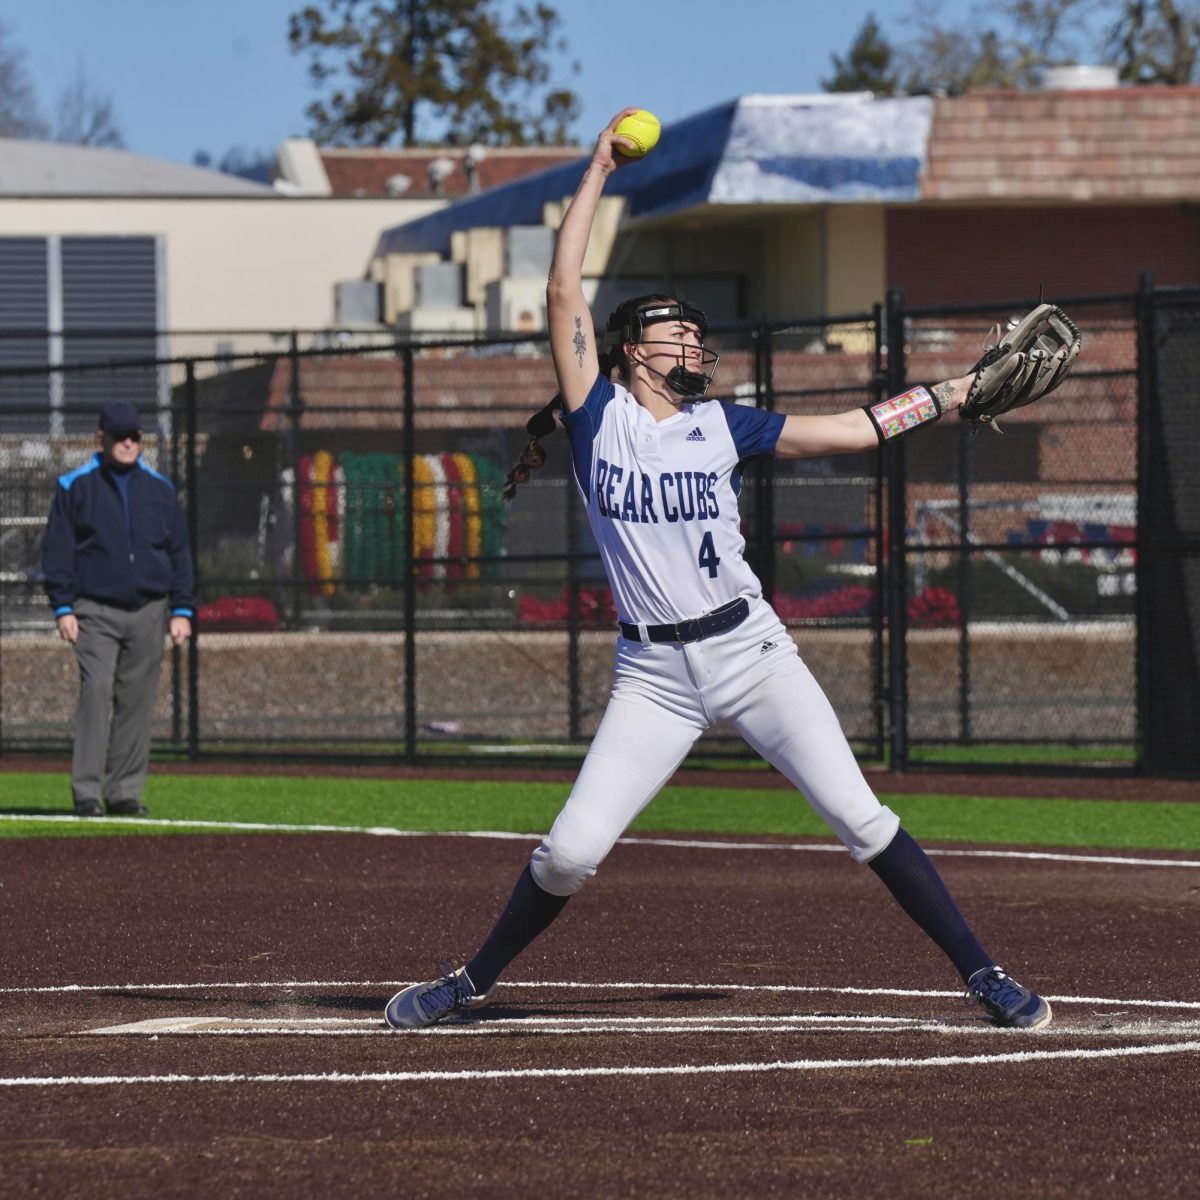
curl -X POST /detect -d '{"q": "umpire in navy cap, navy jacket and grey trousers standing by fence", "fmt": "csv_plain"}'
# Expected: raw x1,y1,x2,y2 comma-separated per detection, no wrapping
42,404,194,817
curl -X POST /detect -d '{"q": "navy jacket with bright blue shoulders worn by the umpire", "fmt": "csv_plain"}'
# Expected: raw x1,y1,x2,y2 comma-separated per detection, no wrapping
42,451,196,618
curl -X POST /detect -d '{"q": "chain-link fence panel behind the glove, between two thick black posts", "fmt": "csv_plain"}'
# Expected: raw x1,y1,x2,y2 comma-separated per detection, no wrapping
896,290,1138,764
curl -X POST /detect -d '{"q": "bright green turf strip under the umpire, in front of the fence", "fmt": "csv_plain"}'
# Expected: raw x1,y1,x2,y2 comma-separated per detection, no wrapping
0,773,1200,851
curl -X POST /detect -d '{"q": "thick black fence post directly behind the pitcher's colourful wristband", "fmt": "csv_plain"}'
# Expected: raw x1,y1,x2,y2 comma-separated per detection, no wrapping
883,288,908,773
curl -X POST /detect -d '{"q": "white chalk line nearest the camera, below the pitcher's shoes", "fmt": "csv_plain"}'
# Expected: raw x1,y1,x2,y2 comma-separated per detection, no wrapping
0,1040,1200,1087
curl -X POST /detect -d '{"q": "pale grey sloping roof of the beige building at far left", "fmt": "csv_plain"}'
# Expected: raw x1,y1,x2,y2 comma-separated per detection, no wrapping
0,138,276,197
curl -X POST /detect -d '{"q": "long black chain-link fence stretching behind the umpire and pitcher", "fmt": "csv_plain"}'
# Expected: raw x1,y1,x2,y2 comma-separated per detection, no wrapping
0,289,1196,767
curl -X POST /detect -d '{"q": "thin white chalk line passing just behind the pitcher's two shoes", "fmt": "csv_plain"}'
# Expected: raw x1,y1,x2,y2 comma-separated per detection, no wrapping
9,979,1200,1012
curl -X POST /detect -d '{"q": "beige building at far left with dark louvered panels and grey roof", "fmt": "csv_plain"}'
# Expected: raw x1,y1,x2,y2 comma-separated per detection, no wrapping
0,139,446,365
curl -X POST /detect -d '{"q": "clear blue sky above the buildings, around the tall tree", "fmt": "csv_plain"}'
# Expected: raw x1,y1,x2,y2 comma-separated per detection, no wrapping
7,0,970,162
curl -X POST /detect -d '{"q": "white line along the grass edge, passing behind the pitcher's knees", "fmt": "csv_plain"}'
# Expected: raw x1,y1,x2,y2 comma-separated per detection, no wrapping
0,812,1200,868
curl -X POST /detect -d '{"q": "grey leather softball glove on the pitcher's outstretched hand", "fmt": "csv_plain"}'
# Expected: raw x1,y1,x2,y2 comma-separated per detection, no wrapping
959,304,1081,428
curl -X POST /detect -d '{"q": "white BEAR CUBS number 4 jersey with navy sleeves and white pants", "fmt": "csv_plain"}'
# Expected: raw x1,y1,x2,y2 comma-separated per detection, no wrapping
530,376,900,895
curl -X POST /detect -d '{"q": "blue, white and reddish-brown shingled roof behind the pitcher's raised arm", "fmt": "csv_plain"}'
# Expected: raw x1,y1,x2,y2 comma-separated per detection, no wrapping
376,88,1200,254
